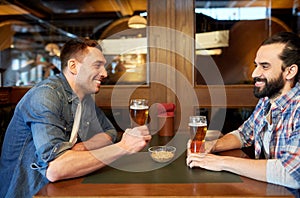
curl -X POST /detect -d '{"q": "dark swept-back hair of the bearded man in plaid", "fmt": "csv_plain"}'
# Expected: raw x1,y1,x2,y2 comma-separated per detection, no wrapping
262,32,300,83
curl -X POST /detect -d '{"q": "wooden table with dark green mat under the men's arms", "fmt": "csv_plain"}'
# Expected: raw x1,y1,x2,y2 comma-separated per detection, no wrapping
35,134,294,198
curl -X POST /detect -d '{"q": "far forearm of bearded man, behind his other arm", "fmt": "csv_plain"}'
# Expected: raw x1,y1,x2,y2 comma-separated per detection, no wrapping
212,133,242,152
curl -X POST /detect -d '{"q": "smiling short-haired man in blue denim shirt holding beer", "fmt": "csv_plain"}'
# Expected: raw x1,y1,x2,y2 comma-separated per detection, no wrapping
0,39,151,197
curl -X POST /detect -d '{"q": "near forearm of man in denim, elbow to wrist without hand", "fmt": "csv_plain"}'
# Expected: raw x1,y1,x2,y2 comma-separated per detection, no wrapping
46,144,128,182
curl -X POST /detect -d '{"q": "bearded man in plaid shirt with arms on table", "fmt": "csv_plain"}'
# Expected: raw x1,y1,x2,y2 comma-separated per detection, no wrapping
187,32,300,192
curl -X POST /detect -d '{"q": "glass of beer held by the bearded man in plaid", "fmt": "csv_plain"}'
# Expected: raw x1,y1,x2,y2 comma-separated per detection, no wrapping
189,116,207,153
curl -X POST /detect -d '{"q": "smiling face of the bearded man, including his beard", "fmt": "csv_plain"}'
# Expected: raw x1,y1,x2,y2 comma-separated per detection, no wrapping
252,43,286,99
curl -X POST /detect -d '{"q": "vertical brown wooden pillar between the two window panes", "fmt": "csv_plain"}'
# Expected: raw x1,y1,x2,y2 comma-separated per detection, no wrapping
148,0,195,128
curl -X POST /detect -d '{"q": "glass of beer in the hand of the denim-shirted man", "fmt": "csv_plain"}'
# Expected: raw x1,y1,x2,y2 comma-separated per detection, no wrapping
130,99,149,128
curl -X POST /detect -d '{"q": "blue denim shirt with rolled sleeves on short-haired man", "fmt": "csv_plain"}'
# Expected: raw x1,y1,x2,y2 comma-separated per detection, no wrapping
0,74,117,198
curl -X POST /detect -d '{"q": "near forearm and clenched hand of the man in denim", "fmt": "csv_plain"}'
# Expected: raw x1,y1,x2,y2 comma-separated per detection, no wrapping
46,126,151,182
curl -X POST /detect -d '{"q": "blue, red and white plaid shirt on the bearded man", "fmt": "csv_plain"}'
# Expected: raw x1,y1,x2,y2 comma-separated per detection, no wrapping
238,83,300,181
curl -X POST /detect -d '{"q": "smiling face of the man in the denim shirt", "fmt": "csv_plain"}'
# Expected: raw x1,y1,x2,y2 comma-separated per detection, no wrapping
75,47,107,98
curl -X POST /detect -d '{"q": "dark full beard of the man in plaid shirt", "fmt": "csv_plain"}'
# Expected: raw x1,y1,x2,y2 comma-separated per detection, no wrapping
253,74,284,99
